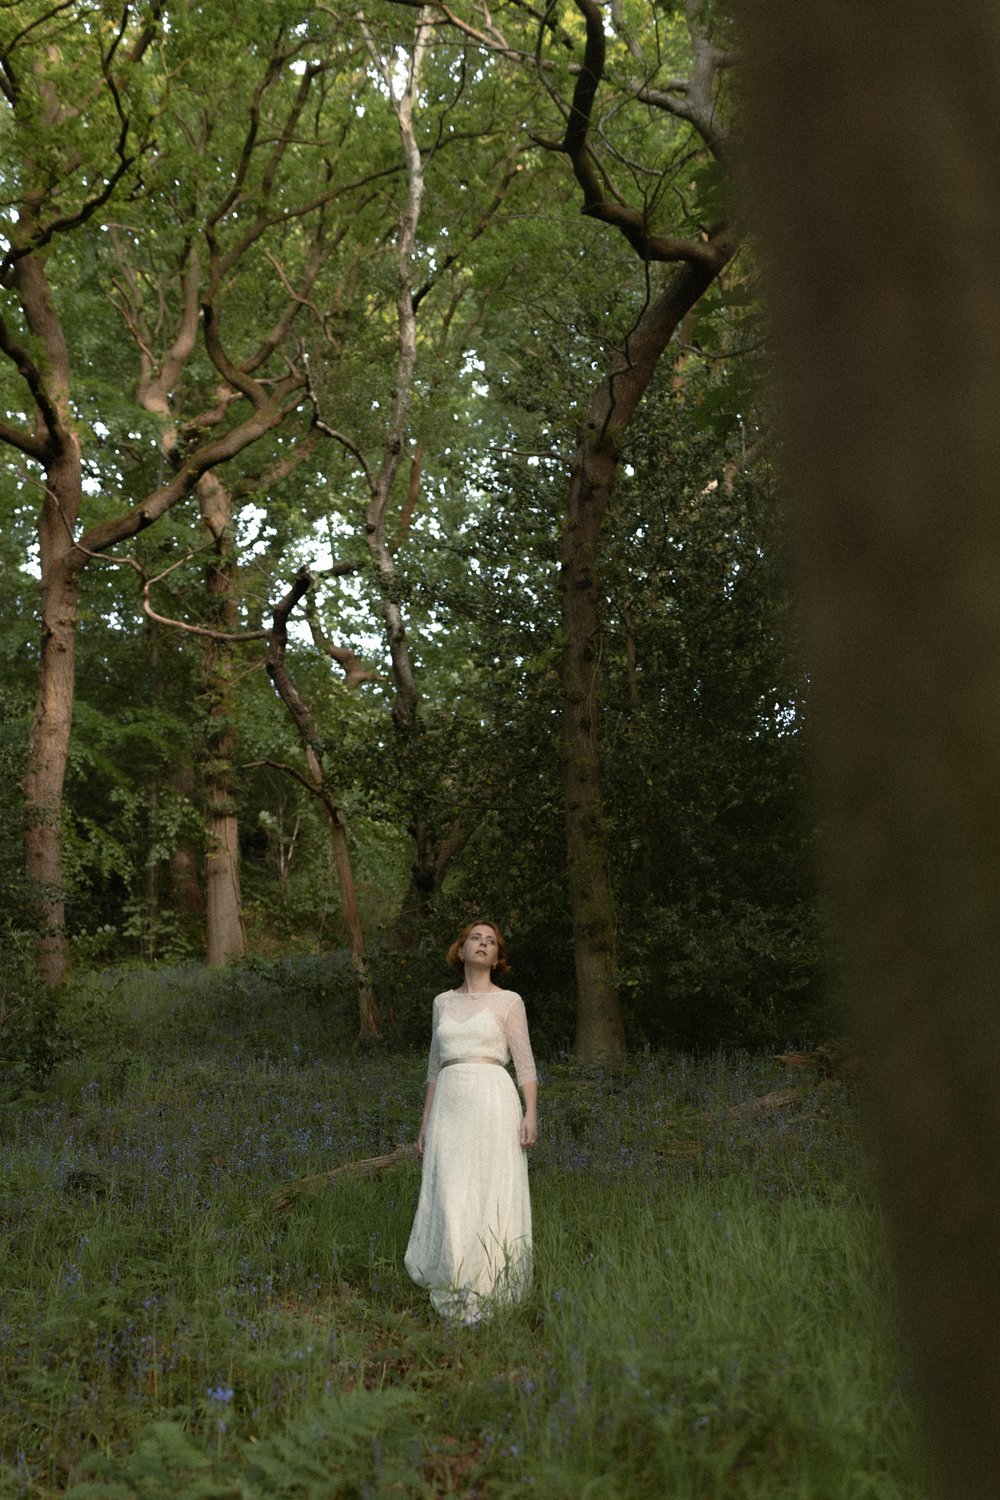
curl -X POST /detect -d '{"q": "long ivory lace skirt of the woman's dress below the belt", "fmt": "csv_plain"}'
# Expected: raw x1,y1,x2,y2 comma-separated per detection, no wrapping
405,1062,531,1323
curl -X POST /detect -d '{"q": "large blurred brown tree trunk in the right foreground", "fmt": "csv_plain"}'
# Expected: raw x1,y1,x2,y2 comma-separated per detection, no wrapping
744,0,1000,1500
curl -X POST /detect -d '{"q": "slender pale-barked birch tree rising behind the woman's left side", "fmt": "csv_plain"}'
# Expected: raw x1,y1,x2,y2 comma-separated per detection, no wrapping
312,9,527,951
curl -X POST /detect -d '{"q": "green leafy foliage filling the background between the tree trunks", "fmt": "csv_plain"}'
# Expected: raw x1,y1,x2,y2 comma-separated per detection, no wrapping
0,0,825,1050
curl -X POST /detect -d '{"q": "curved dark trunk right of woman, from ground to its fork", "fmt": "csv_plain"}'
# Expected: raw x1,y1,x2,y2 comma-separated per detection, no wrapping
561,258,733,1061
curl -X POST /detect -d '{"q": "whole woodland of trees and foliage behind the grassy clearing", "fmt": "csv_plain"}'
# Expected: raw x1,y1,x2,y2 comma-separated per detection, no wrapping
0,0,829,1058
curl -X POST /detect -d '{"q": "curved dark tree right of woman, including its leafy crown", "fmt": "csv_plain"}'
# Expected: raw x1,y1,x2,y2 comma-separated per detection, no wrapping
386,0,736,1058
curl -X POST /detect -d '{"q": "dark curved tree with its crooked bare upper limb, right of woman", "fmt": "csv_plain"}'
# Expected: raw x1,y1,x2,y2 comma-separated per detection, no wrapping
548,0,736,1059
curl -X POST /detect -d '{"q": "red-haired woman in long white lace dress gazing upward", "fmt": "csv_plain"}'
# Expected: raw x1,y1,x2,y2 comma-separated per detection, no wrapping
406,923,538,1323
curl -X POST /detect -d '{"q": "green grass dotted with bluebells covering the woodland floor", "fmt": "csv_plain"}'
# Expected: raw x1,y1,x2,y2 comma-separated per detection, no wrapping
0,975,924,1500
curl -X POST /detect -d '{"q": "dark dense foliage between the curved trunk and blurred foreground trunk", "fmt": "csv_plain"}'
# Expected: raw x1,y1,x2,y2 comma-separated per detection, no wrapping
587,383,829,1046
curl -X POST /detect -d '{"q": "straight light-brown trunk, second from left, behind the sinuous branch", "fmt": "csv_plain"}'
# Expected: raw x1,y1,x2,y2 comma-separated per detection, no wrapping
198,474,246,965
